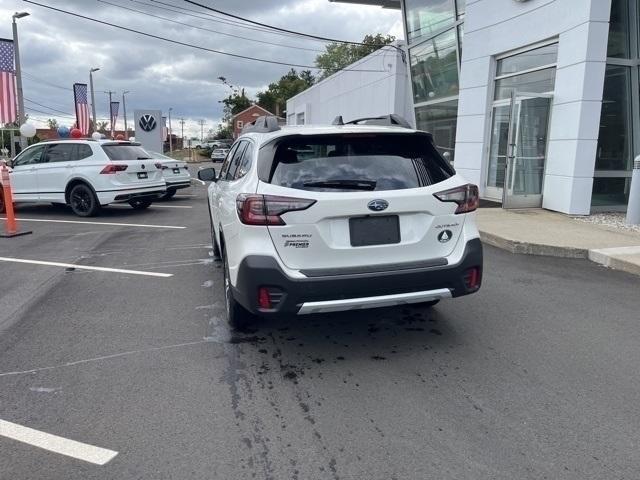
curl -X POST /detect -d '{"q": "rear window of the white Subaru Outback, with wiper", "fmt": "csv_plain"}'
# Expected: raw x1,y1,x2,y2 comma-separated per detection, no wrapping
270,134,455,192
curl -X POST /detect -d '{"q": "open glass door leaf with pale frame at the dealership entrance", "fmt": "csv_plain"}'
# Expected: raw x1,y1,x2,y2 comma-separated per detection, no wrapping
502,94,552,208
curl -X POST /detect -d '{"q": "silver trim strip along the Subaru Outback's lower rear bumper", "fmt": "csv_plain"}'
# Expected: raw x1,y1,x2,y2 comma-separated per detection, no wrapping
298,288,451,315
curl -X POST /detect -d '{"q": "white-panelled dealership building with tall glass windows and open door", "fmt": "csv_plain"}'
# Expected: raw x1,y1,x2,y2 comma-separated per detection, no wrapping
316,0,640,215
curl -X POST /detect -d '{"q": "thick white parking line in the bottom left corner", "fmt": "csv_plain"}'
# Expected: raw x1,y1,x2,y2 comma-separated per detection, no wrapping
0,420,118,465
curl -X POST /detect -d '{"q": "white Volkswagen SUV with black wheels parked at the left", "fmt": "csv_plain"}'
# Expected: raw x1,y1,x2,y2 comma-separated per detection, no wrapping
0,139,167,217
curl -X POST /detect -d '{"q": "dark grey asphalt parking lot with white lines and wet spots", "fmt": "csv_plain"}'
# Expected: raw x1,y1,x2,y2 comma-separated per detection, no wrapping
0,174,640,480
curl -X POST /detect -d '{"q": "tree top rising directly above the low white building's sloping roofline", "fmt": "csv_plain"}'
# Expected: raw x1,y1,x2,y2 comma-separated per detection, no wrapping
316,33,396,79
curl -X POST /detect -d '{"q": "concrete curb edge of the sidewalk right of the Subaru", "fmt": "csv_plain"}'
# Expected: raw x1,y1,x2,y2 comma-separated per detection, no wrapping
480,231,640,276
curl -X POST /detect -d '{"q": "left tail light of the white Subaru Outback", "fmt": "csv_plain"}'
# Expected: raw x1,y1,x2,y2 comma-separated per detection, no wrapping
236,193,316,225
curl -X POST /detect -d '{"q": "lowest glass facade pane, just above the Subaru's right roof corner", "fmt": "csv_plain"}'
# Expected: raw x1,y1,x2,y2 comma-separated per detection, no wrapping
416,100,458,162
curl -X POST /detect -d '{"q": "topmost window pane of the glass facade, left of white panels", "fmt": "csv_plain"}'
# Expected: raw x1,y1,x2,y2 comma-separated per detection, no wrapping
405,0,461,44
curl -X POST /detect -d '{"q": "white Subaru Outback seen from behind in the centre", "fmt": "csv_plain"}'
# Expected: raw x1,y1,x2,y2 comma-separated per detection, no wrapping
199,115,482,325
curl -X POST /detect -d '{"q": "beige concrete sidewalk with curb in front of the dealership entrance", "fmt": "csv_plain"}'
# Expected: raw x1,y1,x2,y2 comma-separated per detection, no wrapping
477,208,640,275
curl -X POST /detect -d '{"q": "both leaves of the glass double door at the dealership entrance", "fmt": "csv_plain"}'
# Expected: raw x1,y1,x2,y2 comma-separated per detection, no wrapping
485,93,552,208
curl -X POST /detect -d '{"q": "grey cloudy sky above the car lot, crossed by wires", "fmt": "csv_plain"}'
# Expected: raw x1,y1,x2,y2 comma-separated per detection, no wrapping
0,0,402,136
